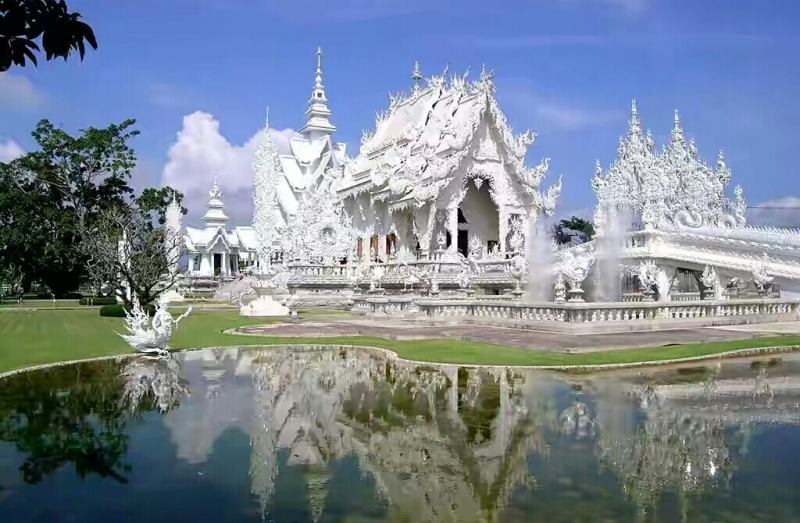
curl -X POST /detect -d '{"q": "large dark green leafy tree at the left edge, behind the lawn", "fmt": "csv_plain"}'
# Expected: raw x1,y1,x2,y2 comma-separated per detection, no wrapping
0,120,139,296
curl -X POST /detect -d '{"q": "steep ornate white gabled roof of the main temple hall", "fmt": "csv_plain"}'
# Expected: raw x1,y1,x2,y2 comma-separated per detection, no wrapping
338,70,547,211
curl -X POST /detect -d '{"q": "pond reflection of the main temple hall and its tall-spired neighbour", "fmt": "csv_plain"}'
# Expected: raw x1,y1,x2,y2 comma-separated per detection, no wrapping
251,350,554,521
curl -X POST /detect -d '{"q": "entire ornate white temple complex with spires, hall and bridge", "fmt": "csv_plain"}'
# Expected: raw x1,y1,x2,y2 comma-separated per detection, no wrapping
180,49,800,324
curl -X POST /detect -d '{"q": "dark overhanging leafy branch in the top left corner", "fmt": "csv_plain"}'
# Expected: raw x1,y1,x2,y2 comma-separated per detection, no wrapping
0,0,97,71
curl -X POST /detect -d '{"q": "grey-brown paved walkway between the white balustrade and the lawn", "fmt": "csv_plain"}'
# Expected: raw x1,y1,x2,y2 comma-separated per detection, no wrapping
238,316,800,352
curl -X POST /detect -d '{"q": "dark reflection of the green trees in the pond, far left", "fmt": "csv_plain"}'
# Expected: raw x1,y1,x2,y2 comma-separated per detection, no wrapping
0,361,172,483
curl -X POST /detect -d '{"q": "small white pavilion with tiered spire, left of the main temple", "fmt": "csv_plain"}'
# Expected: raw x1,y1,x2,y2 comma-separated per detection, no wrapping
186,177,256,278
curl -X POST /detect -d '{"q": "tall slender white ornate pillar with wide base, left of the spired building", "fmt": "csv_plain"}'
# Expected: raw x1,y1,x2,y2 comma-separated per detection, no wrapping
239,108,289,316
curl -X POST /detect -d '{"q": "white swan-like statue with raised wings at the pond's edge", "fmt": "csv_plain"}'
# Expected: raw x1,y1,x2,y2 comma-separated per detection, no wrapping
120,295,192,354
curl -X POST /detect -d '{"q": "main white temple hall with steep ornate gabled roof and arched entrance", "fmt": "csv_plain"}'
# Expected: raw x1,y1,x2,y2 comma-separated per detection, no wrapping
337,65,560,262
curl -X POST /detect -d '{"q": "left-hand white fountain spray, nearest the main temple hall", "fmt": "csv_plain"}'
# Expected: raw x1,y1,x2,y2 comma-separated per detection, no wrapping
523,216,555,301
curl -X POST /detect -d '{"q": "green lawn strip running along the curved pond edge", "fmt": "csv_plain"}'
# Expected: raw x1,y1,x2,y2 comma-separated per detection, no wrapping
0,308,800,372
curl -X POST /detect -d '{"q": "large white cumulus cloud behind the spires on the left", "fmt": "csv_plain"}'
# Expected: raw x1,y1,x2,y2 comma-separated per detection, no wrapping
161,111,294,225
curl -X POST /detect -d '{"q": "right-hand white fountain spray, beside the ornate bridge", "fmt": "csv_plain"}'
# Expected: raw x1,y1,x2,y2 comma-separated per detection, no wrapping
595,207,631,301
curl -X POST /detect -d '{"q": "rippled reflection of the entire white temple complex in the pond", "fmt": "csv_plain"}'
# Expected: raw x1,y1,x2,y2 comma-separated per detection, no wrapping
147,348,800,521
